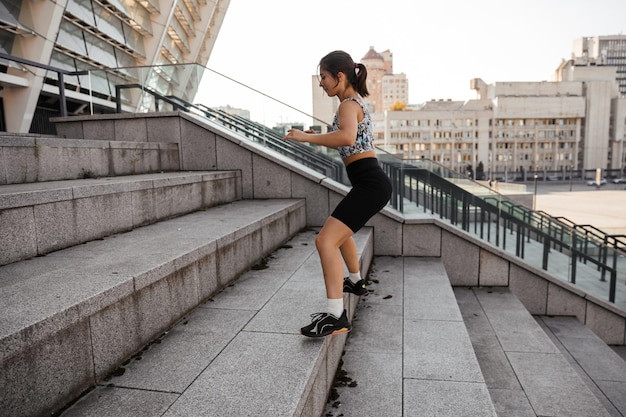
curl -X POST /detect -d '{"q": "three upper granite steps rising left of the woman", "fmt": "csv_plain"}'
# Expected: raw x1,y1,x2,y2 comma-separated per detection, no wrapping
0,128,306,416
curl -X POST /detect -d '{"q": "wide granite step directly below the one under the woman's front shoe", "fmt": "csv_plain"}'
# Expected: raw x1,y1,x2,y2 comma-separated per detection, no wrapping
324,256,496,417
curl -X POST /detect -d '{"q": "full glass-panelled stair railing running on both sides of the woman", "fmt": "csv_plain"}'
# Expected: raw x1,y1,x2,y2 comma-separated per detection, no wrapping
62,64,626,307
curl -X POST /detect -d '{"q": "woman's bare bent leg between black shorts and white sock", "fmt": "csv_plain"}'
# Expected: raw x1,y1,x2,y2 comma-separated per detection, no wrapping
315,217,358,299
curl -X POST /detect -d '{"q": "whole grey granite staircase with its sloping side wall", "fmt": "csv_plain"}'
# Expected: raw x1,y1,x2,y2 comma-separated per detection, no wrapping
0,114,622,417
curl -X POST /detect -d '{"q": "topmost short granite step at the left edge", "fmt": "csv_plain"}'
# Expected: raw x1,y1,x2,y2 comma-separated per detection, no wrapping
0,133,180,184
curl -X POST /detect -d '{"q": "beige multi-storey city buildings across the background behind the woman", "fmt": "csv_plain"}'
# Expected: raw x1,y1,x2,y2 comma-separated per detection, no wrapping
322,41,626,181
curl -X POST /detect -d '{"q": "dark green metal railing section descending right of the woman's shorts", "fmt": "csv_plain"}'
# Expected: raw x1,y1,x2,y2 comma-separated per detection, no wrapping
380,155,626,308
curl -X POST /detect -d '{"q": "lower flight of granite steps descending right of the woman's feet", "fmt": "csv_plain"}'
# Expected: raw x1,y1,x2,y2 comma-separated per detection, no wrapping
324,257,626,417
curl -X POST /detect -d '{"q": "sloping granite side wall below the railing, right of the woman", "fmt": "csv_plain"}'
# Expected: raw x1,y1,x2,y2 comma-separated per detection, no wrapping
400,219,626,345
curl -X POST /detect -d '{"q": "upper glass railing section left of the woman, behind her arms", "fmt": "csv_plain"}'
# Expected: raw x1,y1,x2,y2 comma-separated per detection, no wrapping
83,64,347,184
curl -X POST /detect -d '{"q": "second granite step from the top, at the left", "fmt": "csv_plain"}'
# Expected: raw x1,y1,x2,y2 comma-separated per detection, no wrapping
0,171,242,265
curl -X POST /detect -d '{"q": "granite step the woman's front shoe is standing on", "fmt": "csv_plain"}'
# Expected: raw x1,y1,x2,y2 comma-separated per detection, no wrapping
53,228,373,417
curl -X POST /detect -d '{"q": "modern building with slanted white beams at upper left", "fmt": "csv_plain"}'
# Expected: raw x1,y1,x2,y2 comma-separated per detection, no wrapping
0,0,229,133
